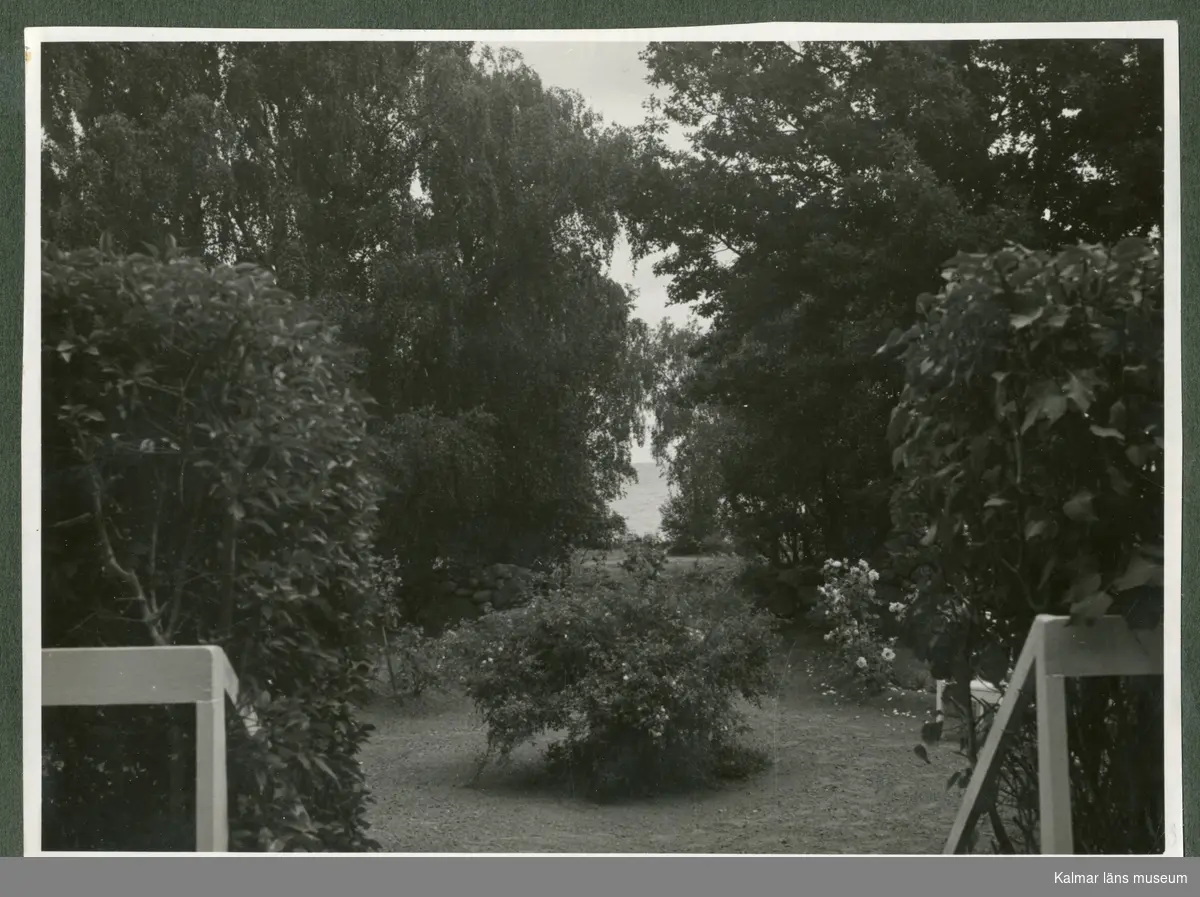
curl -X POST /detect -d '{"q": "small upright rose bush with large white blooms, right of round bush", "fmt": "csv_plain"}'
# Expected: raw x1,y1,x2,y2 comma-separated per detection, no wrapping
817,560,904,692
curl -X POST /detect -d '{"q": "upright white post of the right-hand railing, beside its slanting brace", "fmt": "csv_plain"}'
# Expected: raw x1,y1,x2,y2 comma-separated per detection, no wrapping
1033,618,1075,854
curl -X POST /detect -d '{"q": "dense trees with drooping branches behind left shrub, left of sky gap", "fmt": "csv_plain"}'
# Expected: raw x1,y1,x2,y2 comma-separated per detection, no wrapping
43,43,649,564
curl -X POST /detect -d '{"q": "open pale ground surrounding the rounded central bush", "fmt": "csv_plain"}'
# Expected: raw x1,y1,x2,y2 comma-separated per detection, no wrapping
362,636,961,854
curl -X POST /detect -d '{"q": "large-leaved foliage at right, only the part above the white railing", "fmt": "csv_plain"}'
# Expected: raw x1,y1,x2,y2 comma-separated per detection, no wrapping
892,240,1165,640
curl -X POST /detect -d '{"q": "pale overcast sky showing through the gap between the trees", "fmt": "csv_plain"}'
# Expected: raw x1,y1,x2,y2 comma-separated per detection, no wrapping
503,41,689,463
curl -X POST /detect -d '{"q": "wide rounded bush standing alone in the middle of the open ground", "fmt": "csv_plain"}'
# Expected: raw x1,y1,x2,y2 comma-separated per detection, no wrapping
444,570,775,796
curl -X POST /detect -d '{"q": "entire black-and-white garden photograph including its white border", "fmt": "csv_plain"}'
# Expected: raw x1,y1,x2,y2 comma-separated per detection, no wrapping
24,23,1183,855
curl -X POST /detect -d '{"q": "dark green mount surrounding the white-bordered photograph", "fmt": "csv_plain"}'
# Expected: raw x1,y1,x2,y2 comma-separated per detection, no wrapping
0,0,1200,856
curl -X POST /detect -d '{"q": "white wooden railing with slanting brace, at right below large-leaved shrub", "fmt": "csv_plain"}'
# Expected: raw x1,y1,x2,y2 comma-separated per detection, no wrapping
943,615,1163,854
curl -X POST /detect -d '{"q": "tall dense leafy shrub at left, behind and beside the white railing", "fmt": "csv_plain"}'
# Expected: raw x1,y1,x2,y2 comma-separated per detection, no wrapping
42,247,377,850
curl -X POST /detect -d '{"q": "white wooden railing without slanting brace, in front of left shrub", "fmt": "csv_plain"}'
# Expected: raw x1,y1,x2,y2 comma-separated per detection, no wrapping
42,645,256,853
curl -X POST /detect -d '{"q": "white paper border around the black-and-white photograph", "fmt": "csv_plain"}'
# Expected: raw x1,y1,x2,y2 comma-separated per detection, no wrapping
20,20,1184,857
